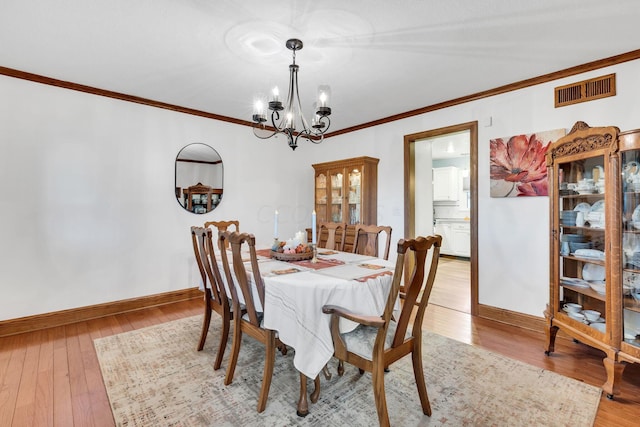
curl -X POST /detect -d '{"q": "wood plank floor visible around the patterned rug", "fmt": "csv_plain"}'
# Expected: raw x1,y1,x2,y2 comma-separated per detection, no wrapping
0,290,640,427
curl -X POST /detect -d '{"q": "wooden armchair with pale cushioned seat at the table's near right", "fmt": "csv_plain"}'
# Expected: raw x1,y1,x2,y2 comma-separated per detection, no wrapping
322,235,442,426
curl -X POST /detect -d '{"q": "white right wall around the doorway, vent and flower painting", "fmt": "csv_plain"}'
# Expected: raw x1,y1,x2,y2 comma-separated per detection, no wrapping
322,60,640,317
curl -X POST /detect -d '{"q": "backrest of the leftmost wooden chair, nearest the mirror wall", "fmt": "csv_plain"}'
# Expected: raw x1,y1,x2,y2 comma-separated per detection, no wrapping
191,226,228,305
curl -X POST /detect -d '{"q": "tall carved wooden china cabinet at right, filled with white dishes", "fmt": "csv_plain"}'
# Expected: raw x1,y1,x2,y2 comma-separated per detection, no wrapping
545,122,640,398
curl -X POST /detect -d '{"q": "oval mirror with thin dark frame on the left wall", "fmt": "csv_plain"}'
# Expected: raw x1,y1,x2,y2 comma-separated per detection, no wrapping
175,142,224,214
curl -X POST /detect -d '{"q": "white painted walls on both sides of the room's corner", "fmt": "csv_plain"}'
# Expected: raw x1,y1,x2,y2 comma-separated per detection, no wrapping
0,61,640,320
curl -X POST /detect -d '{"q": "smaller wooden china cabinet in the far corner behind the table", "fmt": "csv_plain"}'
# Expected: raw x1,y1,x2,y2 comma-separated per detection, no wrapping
313,157,379,250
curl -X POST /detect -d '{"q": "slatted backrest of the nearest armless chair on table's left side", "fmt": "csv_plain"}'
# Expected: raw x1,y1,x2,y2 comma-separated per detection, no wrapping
218,231,264,327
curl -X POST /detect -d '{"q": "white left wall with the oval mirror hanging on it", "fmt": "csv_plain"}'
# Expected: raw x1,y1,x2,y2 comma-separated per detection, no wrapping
0,76,318,320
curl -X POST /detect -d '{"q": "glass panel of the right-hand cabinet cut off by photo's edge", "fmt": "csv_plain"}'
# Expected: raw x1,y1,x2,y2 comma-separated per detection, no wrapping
620,150,640,348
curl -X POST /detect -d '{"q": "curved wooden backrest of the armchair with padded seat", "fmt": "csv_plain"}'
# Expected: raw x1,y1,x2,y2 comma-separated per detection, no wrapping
383,235,442,347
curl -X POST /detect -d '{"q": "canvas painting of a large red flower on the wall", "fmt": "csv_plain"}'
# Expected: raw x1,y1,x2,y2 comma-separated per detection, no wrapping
490,129,566,197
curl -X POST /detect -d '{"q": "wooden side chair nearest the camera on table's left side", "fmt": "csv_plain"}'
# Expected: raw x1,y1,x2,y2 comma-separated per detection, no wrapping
219,231,286,412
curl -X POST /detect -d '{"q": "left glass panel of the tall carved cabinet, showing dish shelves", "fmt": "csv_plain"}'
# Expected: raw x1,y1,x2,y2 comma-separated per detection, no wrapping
554,156,608,339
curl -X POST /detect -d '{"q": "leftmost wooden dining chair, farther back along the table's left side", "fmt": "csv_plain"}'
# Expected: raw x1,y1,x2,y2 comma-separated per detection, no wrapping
191,227,233,370
